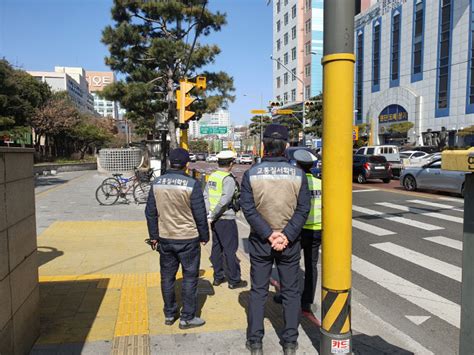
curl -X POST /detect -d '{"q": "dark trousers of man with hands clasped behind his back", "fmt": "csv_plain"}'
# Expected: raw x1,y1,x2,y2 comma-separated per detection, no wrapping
247,234,301,342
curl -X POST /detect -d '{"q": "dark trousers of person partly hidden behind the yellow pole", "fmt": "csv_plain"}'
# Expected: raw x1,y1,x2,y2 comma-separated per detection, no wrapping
301,229,321,310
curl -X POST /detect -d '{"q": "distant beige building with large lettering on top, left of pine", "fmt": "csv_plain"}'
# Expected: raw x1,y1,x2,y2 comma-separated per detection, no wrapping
86,70,119,120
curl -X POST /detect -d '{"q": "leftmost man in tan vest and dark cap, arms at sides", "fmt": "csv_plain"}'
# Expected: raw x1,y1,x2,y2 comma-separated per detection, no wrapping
145,148,209,329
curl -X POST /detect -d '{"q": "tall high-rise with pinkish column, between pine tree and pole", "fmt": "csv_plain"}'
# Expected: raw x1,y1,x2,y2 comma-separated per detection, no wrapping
272,0,324,105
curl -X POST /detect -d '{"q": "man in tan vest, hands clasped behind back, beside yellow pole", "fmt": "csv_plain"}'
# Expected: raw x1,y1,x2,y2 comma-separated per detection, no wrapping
240,124,310,354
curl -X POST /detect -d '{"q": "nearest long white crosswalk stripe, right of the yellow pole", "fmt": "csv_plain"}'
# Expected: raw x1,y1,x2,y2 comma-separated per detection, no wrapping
352,255,461,328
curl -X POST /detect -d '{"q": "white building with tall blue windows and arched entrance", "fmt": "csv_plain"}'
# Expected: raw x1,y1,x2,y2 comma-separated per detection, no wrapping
354,0,474,146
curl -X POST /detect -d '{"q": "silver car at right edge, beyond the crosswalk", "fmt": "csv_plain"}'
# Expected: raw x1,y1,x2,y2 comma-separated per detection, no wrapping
400,160,467,195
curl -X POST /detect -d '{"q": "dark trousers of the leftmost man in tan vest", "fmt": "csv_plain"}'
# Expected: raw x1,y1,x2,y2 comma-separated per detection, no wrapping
158,241,201,320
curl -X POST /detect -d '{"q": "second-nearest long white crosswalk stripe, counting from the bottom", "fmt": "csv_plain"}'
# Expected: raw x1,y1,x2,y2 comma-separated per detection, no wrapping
370,242,462,282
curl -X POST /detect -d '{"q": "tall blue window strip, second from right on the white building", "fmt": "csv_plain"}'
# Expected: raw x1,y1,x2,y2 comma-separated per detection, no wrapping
436,0,452,115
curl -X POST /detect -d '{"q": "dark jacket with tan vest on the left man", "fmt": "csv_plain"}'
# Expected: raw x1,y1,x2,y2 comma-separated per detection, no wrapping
145,170,209,242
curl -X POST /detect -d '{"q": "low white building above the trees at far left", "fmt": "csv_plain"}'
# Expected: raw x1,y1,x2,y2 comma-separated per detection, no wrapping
28,67,95,114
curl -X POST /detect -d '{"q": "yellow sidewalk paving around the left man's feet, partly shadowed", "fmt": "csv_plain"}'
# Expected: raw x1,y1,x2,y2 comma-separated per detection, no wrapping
38,221,254,344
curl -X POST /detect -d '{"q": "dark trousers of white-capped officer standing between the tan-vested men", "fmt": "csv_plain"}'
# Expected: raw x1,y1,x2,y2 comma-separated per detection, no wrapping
211,219,241,284
